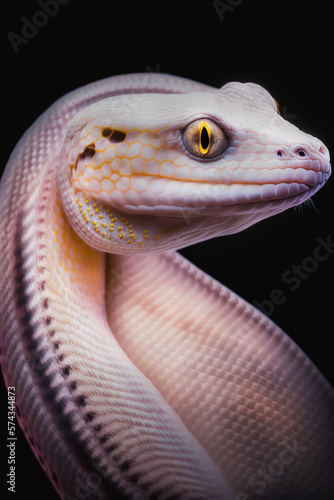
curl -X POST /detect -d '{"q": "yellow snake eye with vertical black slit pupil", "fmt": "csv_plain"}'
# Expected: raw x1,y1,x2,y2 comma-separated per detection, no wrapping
183,120,229,158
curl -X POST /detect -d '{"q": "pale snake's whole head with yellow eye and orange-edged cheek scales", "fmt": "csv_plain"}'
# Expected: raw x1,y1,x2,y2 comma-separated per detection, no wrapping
58,82,330,253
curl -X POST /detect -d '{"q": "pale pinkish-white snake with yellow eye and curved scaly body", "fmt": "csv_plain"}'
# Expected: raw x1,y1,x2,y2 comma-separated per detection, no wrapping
0,74,334,500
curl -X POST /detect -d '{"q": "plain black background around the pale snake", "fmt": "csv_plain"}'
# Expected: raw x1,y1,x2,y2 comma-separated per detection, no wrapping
0,0,334,500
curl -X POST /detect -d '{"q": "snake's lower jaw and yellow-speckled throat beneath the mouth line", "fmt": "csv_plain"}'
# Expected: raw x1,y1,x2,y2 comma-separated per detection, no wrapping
68,180,325,254
